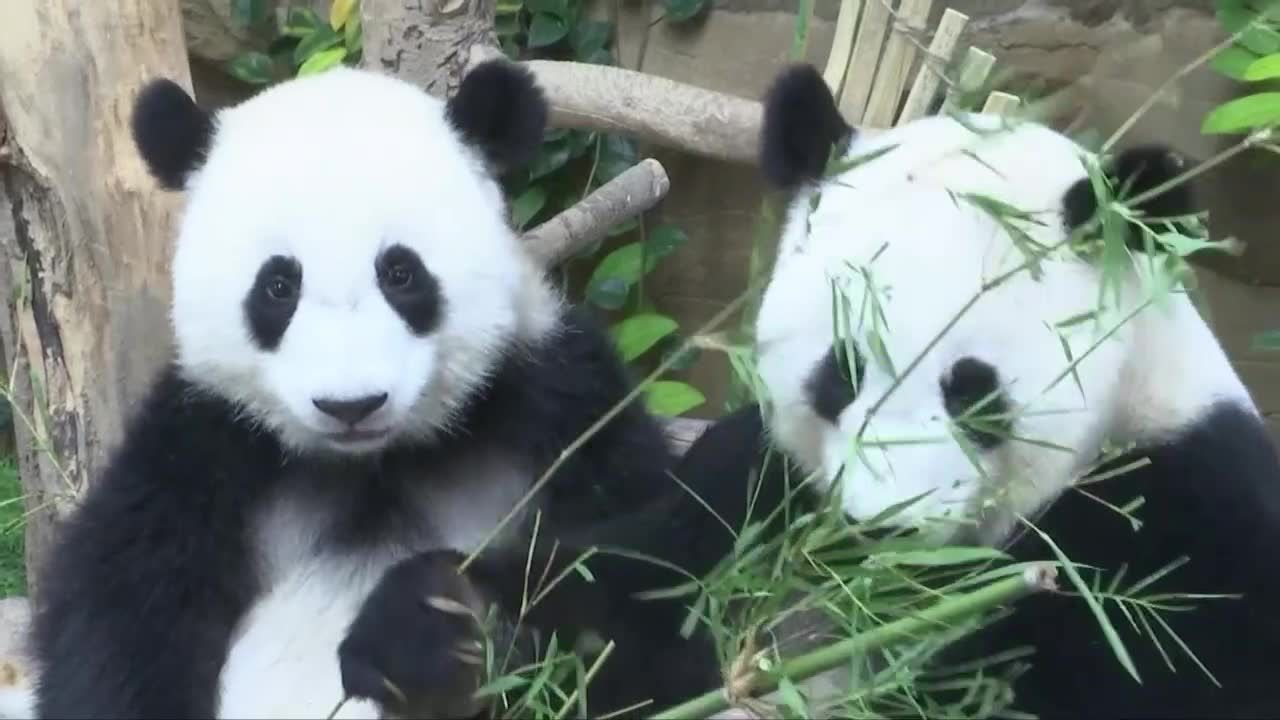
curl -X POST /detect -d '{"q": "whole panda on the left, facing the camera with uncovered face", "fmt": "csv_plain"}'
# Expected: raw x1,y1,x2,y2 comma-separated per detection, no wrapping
32,61,745,717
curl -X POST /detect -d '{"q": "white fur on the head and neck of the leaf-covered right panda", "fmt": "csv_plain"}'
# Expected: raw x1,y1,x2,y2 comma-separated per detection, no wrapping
756,117,1252,541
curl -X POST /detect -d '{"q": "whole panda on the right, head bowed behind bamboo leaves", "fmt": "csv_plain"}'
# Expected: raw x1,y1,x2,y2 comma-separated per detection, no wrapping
756,67,1280,719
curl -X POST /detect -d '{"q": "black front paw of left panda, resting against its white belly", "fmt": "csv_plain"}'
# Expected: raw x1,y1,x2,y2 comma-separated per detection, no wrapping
338,551,485,717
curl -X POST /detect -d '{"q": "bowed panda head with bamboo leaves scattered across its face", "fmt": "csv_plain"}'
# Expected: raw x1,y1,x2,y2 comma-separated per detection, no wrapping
756,67,1252,539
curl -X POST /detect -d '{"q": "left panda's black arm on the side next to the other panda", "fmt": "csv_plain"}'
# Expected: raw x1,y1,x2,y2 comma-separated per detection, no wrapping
455,310,781,711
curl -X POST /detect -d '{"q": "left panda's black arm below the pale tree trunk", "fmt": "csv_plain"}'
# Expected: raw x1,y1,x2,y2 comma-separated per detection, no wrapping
32,370,279,717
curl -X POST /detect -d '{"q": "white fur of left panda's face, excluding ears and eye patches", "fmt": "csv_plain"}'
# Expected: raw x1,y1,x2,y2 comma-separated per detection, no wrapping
173,68,559,450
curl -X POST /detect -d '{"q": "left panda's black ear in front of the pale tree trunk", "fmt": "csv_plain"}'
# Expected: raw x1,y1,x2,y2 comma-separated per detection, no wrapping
132,78,214,190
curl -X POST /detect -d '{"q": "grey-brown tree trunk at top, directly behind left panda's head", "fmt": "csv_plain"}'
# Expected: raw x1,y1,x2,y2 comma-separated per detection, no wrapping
360,0,498,97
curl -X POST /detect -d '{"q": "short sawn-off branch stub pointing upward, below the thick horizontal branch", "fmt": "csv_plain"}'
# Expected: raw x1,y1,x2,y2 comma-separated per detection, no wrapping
524,158,671,266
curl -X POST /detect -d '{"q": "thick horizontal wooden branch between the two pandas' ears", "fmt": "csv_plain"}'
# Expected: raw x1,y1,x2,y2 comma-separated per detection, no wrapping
468,45,764,163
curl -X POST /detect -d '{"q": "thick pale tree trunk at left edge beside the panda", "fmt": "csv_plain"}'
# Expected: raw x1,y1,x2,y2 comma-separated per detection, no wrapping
0,0,191,594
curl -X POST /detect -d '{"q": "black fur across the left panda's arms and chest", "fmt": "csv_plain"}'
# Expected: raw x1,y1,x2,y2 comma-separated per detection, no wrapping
35,303,760,717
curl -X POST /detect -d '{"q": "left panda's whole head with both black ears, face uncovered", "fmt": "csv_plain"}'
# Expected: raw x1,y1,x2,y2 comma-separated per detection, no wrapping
133,61,558,452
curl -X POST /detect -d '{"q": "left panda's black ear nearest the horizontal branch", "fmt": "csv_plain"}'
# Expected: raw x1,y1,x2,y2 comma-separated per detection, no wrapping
448,59,548,173
